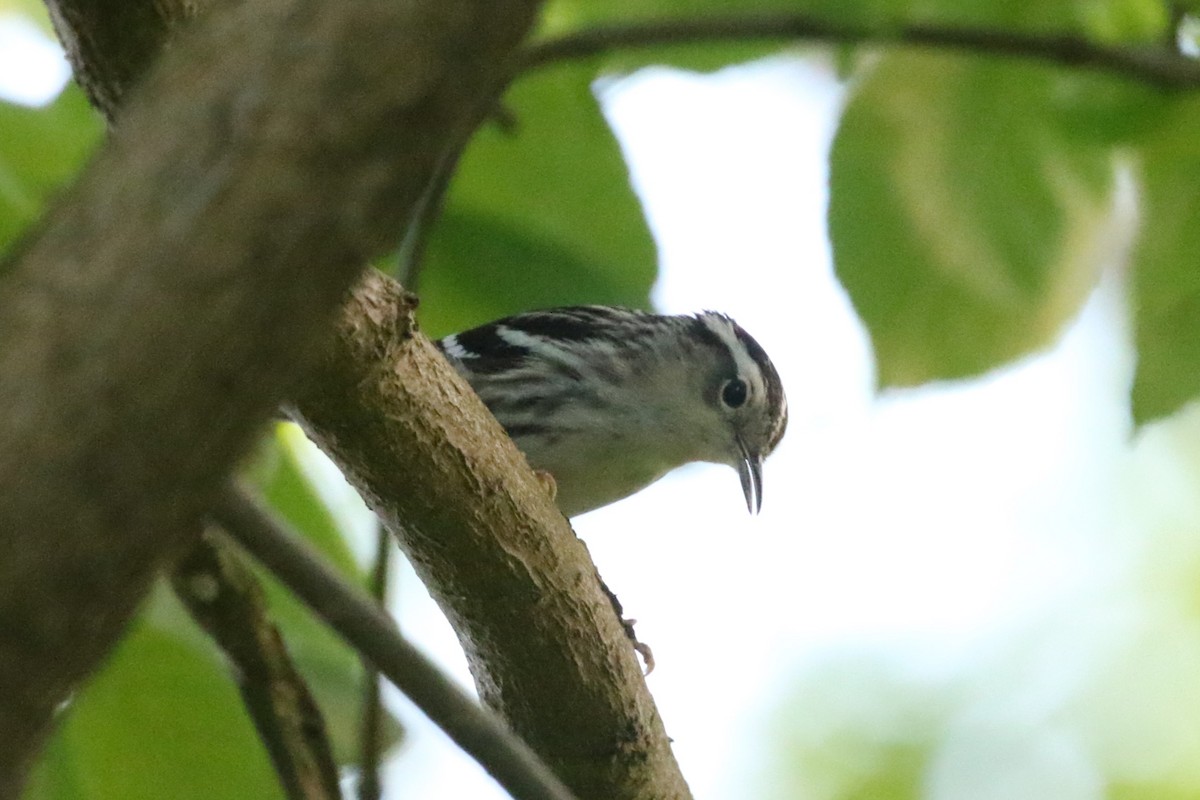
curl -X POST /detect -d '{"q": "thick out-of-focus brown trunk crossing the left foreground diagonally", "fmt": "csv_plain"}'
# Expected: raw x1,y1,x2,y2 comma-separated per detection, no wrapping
0,0,535,796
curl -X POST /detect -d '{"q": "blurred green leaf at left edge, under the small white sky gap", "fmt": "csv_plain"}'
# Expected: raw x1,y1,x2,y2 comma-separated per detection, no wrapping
0,85,103,252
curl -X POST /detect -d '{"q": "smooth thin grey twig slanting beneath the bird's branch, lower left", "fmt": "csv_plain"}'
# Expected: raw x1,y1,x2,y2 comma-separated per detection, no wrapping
212,487,574,800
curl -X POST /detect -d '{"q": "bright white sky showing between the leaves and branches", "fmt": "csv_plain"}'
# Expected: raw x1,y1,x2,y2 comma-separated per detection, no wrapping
0,24,1200,800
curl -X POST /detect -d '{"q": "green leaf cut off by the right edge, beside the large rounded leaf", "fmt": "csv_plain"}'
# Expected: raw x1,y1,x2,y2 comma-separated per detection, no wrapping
1132,96,1200,423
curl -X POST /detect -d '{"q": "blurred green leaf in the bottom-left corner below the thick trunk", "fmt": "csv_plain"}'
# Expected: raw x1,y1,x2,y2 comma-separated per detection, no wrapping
24,609,283,800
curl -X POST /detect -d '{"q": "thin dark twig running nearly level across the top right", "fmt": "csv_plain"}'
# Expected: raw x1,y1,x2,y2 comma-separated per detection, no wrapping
521,14,1200,89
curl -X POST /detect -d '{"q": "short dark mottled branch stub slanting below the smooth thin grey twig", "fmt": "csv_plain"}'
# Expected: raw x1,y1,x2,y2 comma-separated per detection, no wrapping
172,534,342,800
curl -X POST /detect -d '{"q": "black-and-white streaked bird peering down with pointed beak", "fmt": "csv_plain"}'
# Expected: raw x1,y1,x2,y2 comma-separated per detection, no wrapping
437,306,787,517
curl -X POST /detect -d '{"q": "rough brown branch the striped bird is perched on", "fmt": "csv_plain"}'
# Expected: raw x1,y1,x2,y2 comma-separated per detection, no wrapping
284,273,690,800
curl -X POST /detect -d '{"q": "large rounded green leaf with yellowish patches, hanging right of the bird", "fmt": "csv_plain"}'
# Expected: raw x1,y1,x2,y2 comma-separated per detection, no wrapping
829,54,1111,385
